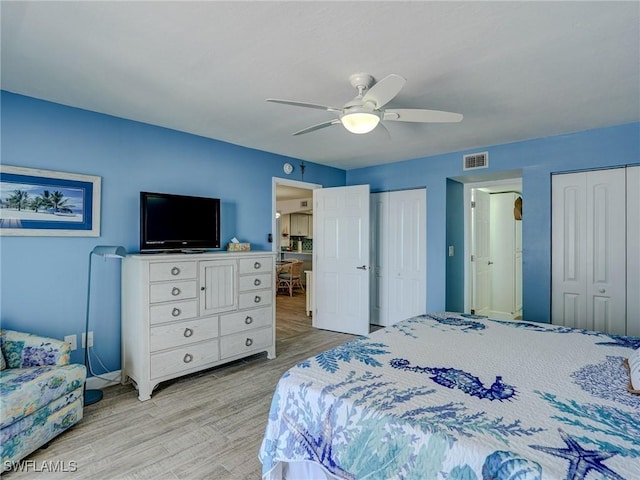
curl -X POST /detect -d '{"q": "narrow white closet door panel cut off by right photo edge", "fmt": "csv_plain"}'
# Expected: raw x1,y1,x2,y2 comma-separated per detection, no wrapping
627,166,640,337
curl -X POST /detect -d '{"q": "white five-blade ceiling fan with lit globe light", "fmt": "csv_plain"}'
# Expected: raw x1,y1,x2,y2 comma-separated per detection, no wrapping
267,73,463,135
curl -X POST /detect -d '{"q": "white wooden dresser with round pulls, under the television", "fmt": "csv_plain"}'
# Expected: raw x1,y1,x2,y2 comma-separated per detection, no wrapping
122,252,276,400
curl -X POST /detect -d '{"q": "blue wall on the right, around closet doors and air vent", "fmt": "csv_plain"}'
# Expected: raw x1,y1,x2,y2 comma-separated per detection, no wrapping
347,123,640,322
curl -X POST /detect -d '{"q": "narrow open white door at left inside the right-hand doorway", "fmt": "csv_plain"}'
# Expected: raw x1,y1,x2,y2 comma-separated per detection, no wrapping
471,189,491,315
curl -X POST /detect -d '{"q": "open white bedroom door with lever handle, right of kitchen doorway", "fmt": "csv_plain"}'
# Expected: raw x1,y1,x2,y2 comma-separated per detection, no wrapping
313,185,369,335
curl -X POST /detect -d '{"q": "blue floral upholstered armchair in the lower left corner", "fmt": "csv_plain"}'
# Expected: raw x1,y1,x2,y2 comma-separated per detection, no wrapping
0,330,87,471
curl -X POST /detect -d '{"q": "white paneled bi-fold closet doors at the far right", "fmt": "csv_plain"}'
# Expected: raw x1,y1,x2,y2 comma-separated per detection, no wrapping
551,167,640,335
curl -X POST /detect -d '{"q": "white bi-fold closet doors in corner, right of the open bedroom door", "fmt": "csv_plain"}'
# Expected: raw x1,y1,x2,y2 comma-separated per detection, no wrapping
369,189,427,326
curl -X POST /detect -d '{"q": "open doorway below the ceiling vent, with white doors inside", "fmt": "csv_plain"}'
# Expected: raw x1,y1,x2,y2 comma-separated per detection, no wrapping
464,178,523,320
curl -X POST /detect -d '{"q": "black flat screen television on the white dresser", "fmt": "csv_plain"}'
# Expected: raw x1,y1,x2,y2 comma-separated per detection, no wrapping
140,192,220,253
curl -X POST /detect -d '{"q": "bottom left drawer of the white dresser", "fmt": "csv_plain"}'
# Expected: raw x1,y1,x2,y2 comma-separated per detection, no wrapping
151,339,220,378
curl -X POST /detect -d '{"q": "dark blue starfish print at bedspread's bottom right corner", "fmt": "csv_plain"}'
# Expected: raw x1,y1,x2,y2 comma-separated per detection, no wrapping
530,428,625,480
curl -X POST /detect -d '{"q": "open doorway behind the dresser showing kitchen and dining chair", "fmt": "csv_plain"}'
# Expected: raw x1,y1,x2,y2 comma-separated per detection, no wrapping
272,178,322,322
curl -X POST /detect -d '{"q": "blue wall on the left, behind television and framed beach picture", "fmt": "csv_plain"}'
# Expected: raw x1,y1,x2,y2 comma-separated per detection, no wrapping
0,92,345,370
